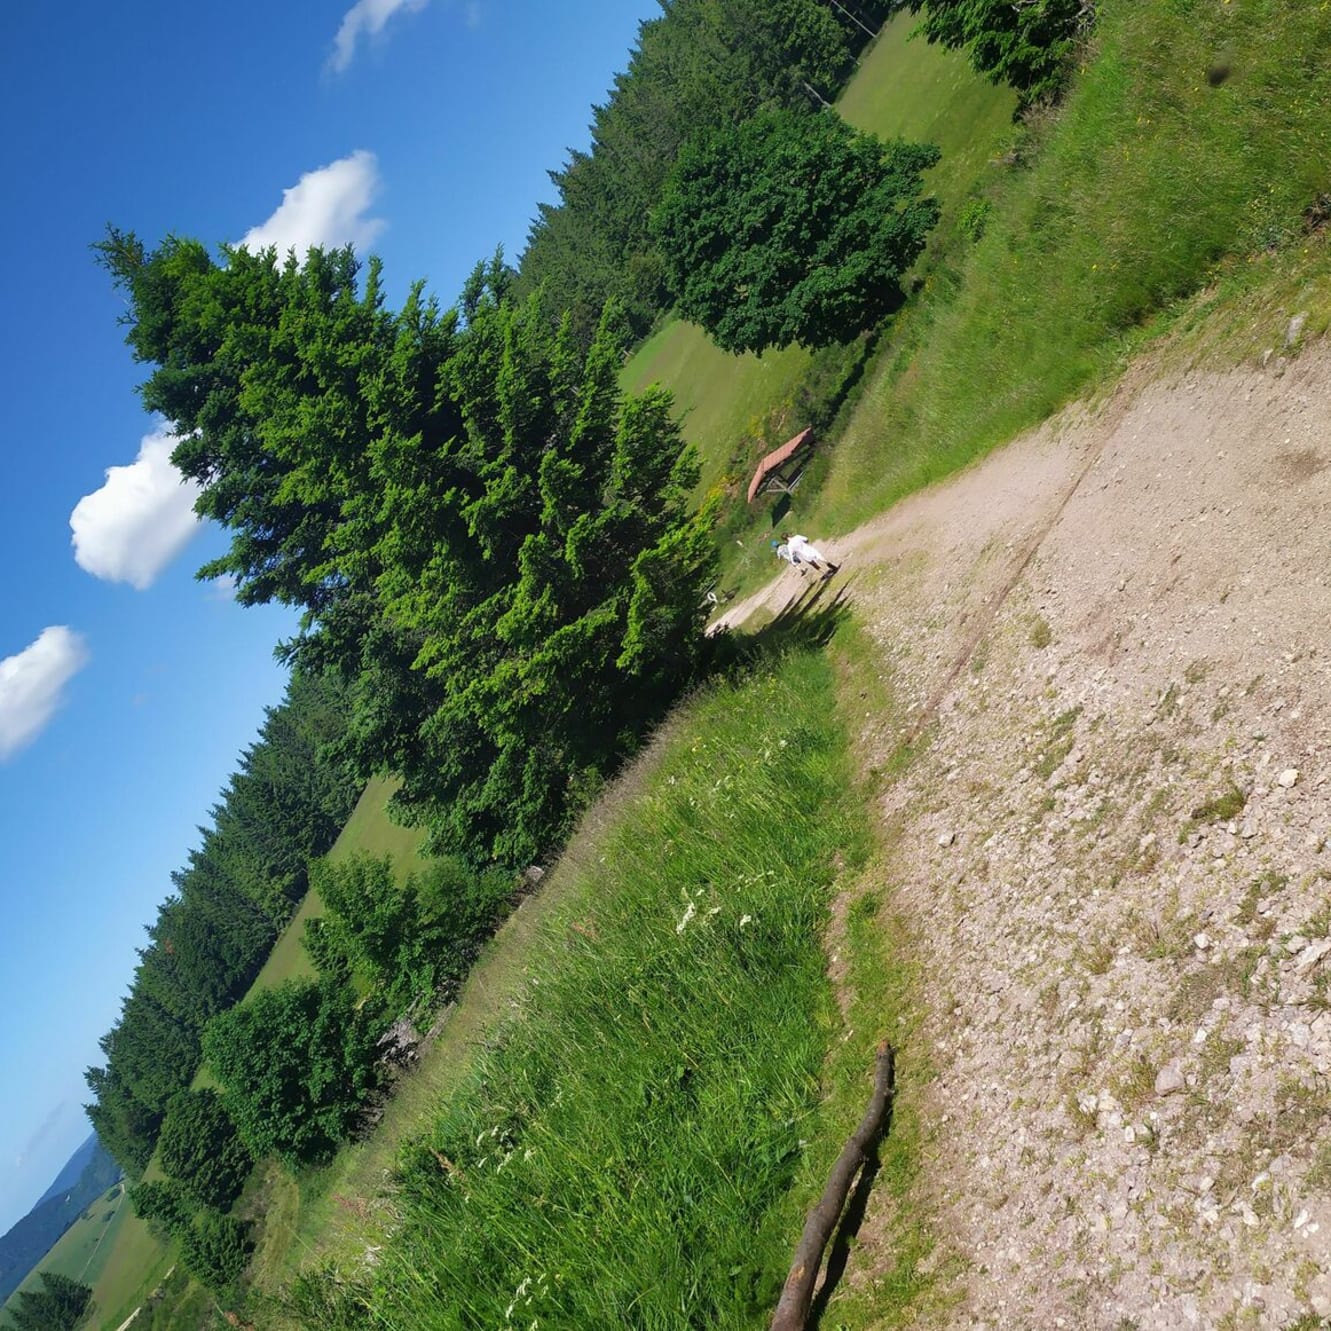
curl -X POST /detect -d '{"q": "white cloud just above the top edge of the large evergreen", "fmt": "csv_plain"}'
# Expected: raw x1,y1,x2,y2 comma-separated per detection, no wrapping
241,148,383,258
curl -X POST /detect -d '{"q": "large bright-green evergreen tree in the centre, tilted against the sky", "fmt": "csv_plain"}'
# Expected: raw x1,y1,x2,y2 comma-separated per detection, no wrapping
93,230,712,864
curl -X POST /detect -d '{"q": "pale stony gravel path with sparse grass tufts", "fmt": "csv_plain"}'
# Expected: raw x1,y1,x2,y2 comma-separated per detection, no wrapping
745,346,1331,1331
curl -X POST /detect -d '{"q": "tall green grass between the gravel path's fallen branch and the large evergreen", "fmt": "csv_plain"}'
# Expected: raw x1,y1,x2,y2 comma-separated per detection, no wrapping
288,654,866,1331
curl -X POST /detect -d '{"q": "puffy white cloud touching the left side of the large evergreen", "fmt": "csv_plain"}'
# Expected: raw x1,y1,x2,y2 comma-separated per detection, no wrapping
69,430,200,591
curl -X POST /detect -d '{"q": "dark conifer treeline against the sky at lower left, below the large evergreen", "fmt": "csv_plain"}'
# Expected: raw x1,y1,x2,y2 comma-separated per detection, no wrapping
87,671,361,1175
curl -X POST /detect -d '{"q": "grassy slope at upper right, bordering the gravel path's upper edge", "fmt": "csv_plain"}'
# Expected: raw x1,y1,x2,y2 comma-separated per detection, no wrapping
809,0,1331,530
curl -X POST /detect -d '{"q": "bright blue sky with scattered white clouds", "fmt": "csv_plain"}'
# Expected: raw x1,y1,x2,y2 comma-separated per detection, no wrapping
0,0,659,1233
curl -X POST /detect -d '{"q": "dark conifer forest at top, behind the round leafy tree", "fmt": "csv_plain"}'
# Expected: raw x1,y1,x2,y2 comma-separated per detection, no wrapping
518,0,901,339
